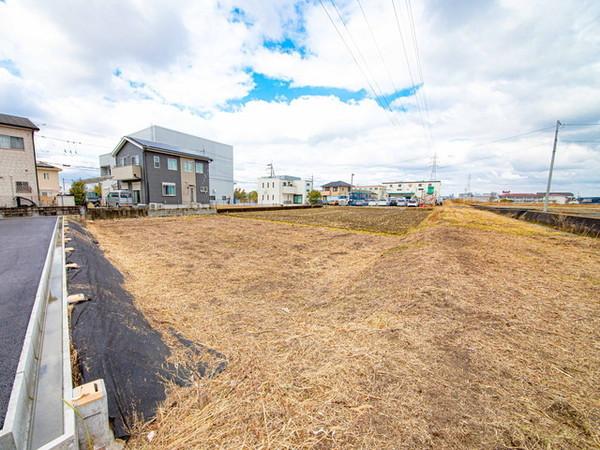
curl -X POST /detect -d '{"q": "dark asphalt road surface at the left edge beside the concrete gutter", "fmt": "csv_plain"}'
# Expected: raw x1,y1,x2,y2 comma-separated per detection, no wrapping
0,217,57,428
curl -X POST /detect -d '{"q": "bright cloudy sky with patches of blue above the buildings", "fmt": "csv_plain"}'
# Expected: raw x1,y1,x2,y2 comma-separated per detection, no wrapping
0,0,600,195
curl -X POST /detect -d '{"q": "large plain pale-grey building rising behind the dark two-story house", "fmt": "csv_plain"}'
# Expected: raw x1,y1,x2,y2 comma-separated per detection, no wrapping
128,125,233,203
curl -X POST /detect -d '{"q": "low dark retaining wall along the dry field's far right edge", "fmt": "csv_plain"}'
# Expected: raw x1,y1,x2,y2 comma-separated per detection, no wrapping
473,205,600,237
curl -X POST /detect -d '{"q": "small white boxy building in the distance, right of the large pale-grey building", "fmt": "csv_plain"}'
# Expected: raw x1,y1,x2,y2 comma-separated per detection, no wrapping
256,175,313,205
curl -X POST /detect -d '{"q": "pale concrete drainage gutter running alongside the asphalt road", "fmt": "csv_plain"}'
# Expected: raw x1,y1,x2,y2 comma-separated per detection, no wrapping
0,217,77,450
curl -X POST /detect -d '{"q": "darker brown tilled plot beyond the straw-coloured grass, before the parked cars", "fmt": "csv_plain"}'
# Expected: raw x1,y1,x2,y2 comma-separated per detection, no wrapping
226,206,431,234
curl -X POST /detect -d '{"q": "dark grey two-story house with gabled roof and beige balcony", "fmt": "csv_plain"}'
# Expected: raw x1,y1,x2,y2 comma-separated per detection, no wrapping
111,136,212,206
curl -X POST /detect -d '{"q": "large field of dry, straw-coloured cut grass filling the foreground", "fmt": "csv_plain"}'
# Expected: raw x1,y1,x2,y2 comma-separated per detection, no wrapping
89,207,600,449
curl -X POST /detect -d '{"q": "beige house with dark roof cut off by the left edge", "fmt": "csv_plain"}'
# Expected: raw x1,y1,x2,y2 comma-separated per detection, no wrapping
0,114,39,207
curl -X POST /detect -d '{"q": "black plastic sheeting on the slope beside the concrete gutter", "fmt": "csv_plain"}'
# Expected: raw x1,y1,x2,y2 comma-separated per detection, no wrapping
68,221,227,438
